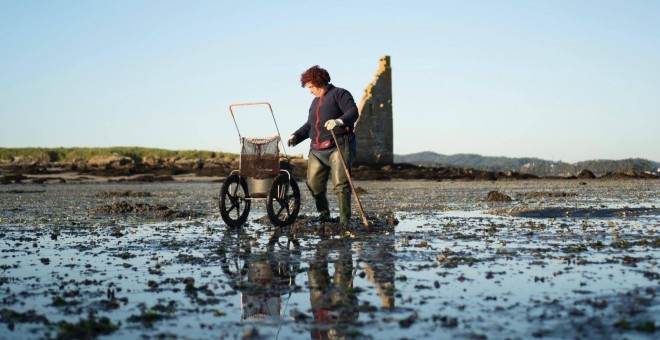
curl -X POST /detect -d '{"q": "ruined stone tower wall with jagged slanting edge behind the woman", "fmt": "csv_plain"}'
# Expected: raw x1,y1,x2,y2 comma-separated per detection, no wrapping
355,56,394,165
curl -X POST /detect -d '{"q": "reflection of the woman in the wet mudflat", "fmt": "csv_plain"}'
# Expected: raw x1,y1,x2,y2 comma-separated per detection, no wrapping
308,241,358,339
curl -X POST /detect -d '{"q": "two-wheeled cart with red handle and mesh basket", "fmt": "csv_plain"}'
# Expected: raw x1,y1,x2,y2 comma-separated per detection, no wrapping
220,102,300,228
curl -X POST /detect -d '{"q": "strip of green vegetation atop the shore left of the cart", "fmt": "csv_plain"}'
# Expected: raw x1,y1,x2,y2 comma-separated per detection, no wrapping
0,147,238,163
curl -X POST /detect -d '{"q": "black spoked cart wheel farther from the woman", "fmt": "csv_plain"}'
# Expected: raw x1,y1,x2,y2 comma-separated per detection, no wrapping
220,174,251,228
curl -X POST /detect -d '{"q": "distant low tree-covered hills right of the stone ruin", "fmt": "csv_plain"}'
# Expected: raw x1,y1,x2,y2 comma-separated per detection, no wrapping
394,151,660,177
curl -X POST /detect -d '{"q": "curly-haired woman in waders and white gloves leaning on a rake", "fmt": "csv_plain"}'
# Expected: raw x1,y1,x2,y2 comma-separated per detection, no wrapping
288,65,359,226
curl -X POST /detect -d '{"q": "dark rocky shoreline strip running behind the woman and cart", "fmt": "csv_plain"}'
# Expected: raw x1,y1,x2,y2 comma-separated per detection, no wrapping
0,157,660,185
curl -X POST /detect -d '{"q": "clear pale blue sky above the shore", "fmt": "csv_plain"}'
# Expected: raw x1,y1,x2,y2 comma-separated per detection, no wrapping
0,0,660,162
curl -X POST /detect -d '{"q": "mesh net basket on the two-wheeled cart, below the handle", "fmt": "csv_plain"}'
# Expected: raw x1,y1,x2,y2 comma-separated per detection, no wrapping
241,136,280,179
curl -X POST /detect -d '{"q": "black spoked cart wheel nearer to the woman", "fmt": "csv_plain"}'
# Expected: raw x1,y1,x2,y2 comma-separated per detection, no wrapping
266,174,300,227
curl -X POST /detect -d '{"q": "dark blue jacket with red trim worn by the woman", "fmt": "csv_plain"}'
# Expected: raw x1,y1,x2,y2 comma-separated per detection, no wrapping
293,84,358,144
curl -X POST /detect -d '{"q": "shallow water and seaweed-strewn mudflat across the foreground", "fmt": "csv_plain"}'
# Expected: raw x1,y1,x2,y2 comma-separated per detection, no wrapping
0,180,660,339
